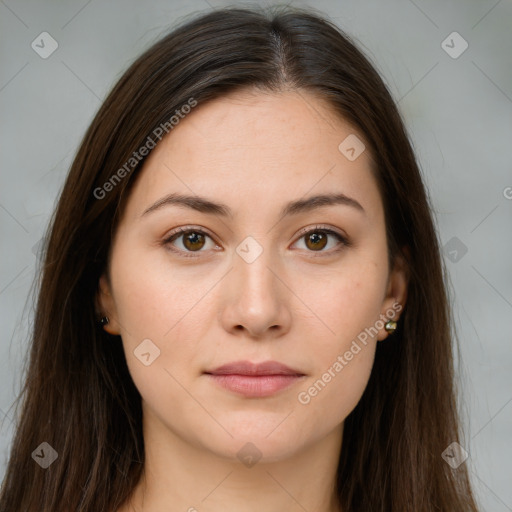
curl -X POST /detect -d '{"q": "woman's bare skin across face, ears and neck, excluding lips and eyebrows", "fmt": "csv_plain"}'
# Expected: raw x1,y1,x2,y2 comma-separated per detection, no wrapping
98,90,407,512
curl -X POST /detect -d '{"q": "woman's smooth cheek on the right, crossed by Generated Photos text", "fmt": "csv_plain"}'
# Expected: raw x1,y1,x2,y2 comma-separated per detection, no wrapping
297,259,386,424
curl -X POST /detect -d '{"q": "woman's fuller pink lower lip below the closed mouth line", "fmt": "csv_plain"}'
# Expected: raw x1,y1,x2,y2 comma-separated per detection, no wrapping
207,374,304,398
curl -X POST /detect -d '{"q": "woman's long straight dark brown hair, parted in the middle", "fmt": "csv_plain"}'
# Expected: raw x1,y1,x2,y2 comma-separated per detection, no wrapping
0,8,477,512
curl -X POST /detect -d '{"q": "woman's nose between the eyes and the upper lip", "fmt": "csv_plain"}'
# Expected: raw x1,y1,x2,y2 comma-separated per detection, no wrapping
221,244,293,339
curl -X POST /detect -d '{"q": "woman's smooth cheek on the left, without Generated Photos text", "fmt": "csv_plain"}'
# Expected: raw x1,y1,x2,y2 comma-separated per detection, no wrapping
112,244,212,396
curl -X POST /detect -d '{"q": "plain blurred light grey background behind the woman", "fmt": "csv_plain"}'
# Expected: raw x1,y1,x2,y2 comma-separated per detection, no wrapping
0,0,512,512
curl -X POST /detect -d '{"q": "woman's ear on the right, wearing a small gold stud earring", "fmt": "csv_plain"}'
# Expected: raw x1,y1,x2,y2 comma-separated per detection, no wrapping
377,246,410,341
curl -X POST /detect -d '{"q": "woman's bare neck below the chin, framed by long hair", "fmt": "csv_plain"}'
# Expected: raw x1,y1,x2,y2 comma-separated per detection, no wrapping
118,410,343,512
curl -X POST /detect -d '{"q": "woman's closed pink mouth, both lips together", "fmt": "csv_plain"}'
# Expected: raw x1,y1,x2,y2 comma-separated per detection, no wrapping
204,361,306,398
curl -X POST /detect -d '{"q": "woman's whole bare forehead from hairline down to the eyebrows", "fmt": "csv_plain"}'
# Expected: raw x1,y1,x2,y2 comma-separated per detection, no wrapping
122,90,380,221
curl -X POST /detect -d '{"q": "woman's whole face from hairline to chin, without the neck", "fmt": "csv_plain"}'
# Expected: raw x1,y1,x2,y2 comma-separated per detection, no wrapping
99,91,406,461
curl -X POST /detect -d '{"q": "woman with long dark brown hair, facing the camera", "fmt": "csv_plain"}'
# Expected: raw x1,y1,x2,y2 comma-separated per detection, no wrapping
0,5,477,512
